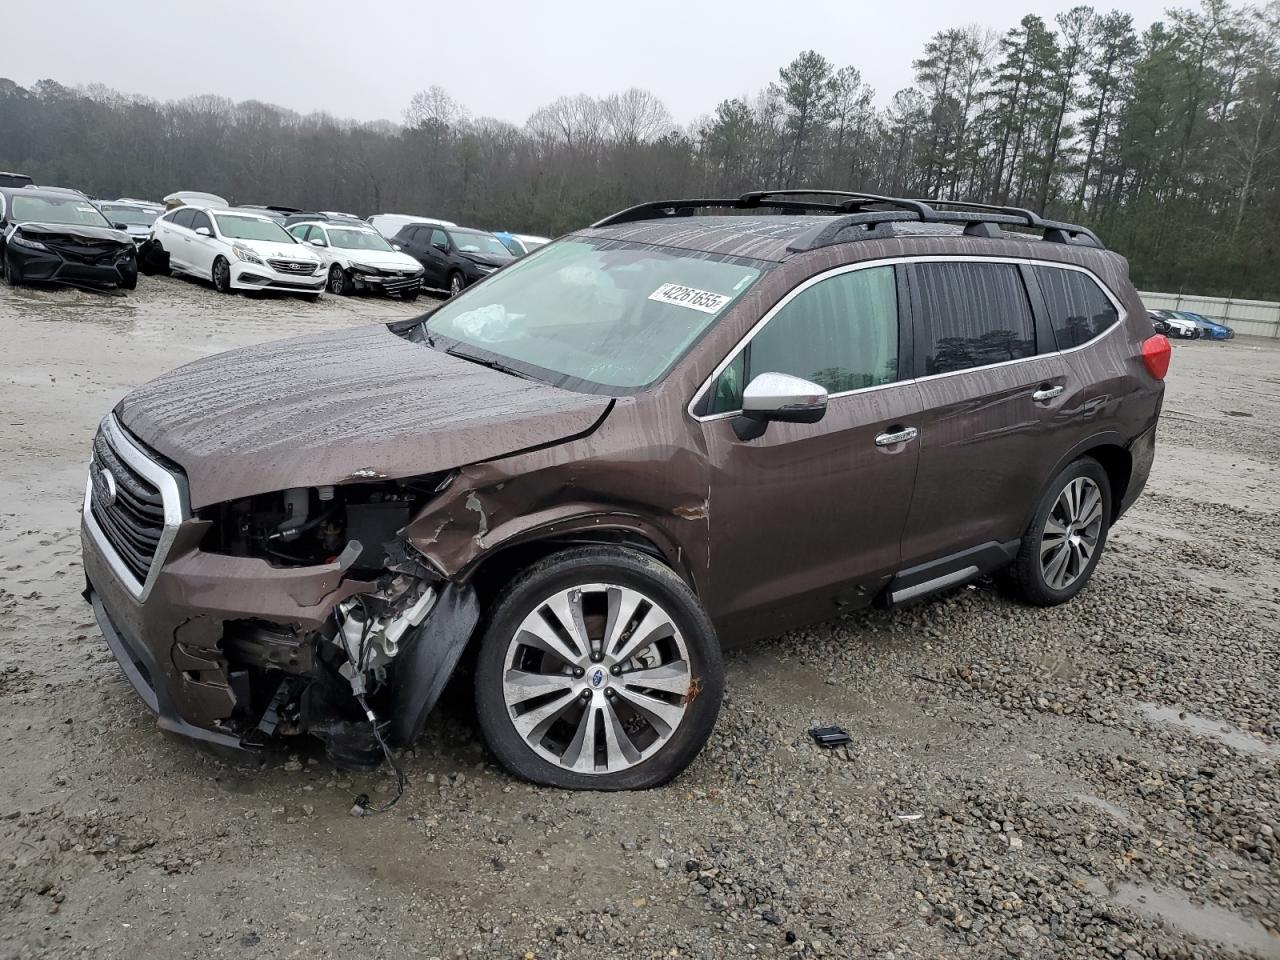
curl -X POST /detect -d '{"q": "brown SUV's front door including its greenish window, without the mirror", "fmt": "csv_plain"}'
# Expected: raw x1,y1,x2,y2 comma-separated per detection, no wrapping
700,266,920,639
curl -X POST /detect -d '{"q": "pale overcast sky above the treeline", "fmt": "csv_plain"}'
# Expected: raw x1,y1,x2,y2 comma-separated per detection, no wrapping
0,0,1172,124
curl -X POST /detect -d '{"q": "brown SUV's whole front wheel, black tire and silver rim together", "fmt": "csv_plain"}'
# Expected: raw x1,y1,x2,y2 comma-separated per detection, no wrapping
475,547,724,790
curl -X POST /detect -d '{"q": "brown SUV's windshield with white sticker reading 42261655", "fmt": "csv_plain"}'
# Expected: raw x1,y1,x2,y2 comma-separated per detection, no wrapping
425,238,767,393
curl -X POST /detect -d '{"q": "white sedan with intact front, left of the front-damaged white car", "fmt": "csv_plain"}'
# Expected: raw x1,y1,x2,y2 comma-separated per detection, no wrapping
152,205,325,297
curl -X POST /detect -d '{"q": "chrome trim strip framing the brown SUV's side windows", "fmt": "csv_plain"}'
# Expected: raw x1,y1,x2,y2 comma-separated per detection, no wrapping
685,253,1129,422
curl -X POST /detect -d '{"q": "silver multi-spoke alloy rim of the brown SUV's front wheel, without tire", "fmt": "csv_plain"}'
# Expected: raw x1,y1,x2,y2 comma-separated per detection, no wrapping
502,584,695,774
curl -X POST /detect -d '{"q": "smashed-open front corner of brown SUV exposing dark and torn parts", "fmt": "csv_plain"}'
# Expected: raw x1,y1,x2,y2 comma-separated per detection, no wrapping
184,475,477,808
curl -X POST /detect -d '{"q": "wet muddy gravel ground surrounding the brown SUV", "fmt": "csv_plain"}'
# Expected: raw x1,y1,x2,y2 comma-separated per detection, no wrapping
0,278,1280,960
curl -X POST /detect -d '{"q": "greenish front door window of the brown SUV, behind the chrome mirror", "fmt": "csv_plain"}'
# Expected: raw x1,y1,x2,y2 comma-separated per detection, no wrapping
707,266,899,413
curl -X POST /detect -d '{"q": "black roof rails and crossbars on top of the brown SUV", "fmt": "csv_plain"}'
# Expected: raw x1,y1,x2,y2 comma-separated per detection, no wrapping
591,189,1103,252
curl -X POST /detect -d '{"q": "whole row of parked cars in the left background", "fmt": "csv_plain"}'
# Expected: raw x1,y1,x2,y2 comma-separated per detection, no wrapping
0,173,549,300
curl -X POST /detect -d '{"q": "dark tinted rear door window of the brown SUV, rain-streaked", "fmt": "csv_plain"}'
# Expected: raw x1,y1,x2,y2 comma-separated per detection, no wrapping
911,261,1036,376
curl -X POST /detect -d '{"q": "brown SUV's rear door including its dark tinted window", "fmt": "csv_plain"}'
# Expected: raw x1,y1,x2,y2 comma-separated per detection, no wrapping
902,259,1071,567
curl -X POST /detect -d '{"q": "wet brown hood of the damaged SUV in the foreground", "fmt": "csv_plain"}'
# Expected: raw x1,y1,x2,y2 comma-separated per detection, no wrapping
115,324,612,508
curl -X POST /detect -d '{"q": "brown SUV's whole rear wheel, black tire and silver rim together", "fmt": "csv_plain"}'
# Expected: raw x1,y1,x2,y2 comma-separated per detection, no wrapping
1002,457,1111,607
